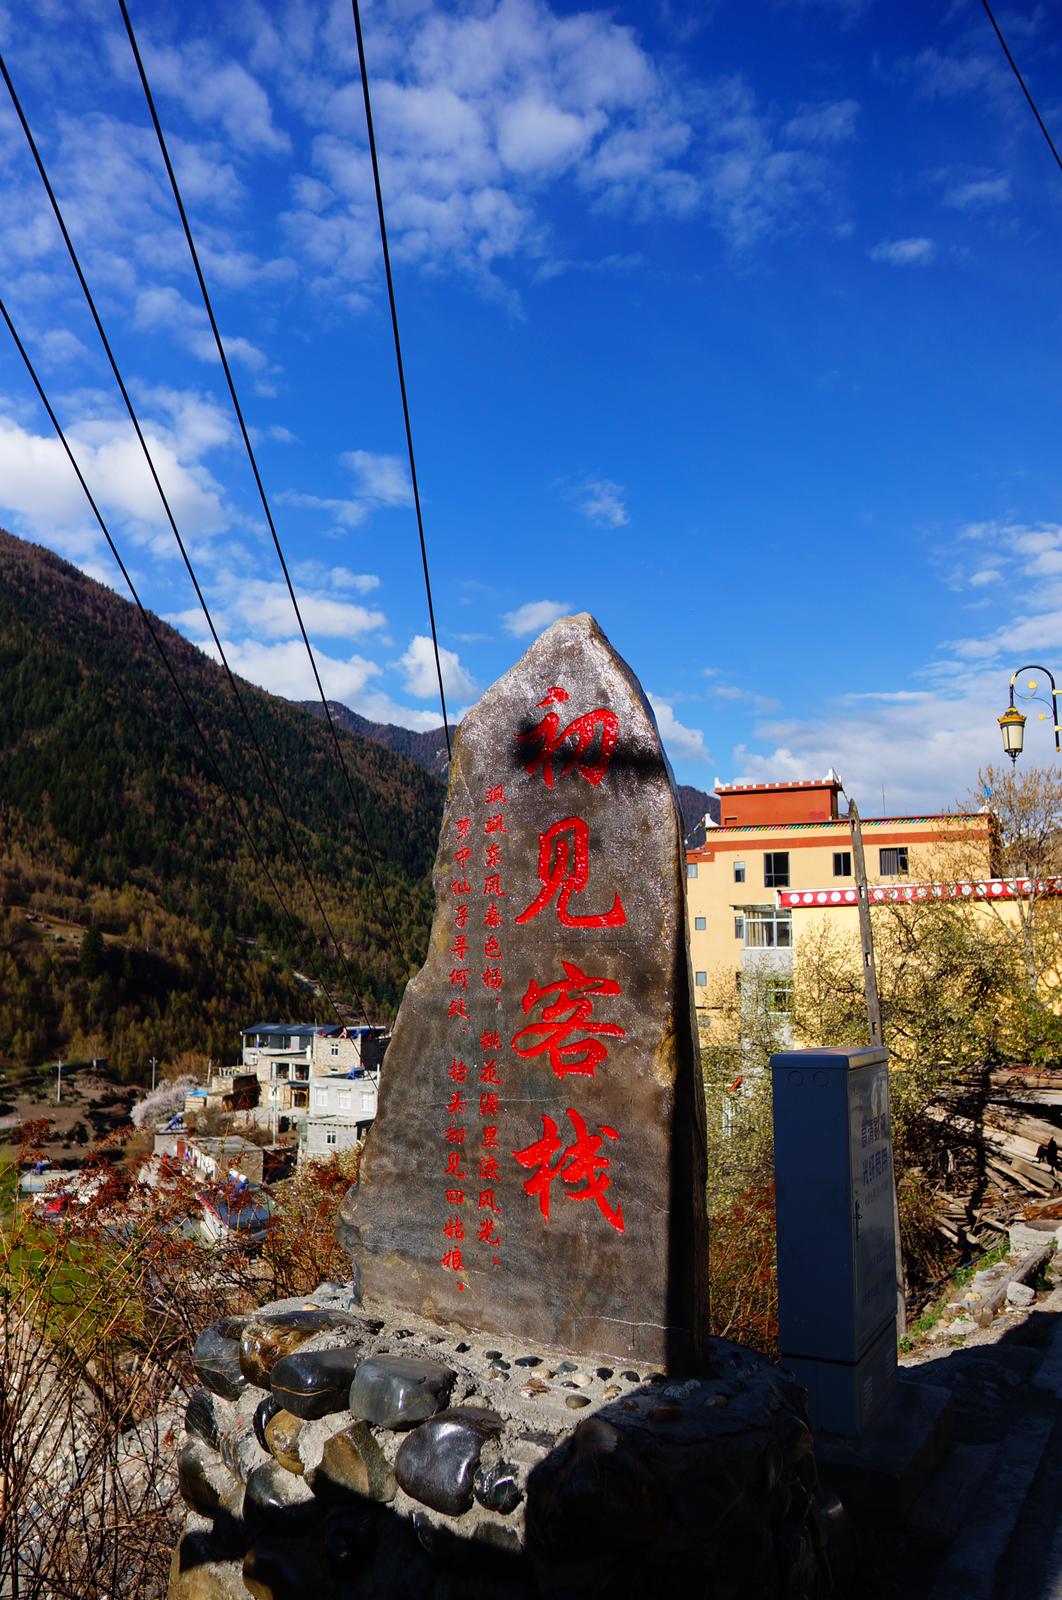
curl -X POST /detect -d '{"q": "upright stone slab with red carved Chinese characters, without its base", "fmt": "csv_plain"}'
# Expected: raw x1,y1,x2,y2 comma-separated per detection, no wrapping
339,616,707,1370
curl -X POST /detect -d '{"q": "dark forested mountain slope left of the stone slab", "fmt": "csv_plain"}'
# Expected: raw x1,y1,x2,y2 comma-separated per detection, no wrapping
0,530,443,1070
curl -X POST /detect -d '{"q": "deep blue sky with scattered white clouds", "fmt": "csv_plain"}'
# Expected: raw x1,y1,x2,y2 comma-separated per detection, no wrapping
0,0,1062,813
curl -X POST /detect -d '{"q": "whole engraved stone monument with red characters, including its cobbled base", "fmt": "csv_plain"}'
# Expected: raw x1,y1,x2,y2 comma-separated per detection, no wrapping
170,616,836,1600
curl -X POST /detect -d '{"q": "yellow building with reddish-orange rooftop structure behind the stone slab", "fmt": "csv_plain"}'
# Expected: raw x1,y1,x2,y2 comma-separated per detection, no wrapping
686,773,1000,1011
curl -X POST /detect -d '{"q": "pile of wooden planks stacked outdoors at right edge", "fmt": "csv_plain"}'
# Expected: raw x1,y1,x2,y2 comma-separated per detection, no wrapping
926,1067,1062,1248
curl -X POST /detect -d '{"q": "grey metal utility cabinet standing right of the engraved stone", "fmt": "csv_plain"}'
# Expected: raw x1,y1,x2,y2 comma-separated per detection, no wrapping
771,1046,897,1437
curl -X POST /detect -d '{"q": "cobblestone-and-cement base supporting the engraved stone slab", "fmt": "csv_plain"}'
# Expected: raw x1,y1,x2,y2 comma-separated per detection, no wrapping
170,1283,844,1600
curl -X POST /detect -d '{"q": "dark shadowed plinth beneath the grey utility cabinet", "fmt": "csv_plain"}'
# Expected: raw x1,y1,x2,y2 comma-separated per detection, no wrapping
814,1376,953,1525
